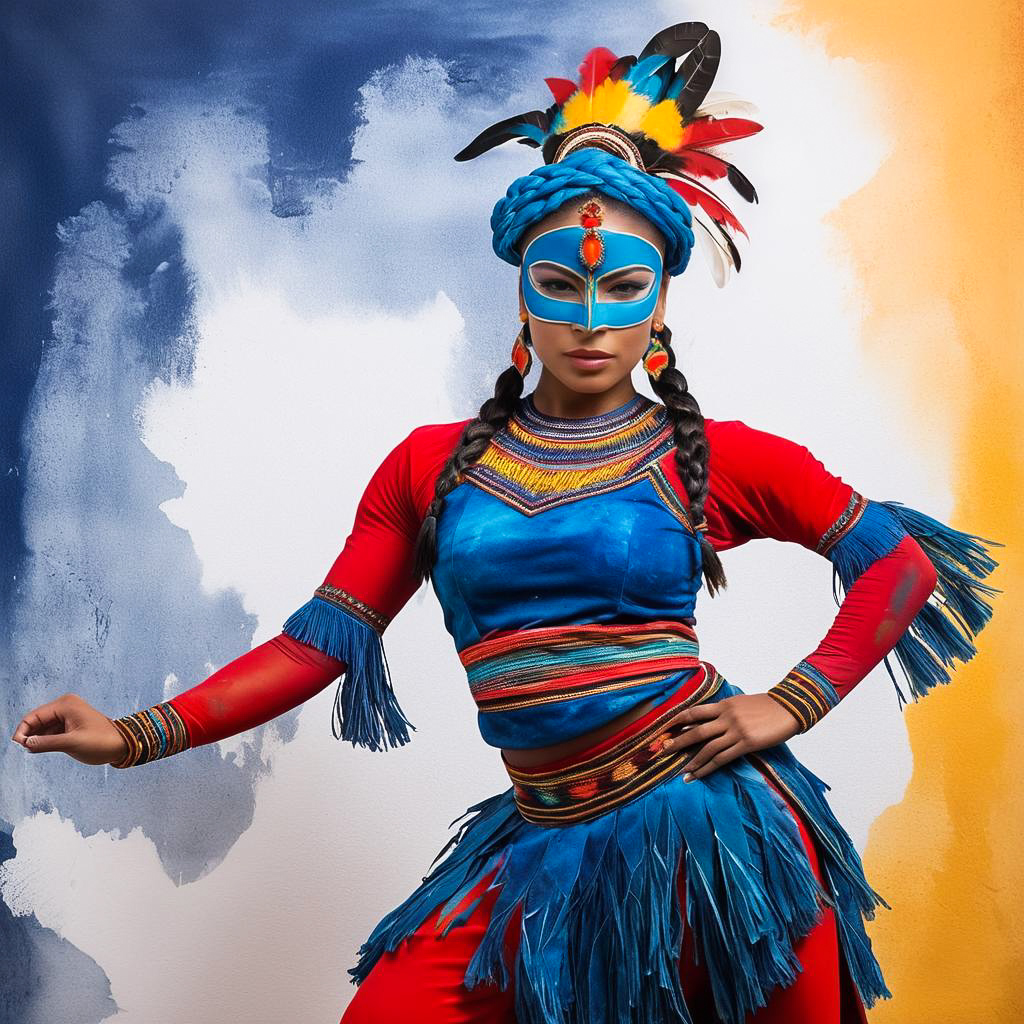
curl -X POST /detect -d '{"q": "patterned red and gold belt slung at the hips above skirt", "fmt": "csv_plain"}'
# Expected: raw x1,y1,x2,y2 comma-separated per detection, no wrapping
502,663,723,825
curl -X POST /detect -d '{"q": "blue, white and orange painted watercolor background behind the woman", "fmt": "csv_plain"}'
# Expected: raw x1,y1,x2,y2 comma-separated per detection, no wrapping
0,0,1024,1024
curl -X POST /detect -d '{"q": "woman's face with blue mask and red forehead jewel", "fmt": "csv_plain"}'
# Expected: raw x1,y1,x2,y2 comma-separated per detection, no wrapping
519,196,670,392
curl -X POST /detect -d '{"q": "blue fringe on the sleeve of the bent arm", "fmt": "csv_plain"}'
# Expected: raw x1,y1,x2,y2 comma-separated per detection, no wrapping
827,501,1002,707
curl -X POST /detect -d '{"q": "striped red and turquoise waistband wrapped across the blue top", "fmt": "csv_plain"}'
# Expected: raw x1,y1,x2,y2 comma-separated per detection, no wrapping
459,620,700,712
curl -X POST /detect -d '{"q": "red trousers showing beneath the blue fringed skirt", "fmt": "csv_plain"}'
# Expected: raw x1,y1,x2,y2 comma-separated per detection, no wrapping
341,781,867,1024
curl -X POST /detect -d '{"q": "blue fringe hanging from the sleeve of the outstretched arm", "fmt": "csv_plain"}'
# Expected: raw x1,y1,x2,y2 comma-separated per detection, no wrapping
284,597,416,751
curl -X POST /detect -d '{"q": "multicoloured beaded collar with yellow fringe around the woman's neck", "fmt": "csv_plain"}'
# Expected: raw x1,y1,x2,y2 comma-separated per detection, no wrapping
461,394,674,515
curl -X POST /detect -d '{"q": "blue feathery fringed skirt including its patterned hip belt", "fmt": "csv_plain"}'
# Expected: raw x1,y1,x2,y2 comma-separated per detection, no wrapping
349,663,889,1024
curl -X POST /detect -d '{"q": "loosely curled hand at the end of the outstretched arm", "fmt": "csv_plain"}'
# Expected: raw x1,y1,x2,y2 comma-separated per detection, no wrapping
10,693,128,765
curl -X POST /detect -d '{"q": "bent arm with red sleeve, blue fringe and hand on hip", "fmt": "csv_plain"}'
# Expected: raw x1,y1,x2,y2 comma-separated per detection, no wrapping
655,421,995,778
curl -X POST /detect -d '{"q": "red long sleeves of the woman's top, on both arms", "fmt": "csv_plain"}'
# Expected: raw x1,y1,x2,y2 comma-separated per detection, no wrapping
151,411,950,756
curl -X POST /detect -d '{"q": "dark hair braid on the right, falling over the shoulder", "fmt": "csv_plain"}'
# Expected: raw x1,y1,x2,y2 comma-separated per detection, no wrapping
648,325,726,596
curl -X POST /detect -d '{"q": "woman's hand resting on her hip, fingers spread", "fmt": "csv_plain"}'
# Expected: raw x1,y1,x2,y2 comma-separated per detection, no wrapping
662,693,800,782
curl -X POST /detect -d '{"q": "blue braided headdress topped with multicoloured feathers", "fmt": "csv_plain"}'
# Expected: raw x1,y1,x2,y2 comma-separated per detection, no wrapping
455,22,762,287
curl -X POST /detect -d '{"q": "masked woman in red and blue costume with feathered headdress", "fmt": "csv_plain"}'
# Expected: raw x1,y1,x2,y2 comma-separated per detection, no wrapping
12,23,994,1024
